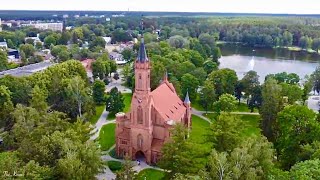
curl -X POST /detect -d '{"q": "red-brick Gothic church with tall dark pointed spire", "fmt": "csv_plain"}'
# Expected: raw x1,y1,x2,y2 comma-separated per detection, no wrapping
115,37,191,164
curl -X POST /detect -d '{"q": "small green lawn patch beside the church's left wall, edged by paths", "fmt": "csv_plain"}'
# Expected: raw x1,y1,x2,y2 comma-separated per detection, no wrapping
99,124,116,151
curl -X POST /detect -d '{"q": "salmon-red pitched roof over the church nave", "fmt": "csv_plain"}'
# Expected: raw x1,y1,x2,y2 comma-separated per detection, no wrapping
151,81,186,122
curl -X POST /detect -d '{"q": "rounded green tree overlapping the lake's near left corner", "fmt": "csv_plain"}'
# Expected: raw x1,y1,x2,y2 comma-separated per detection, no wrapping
208,68,238,97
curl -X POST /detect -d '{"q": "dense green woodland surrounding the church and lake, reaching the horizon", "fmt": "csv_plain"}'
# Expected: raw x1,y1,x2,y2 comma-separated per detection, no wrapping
0,16,320,180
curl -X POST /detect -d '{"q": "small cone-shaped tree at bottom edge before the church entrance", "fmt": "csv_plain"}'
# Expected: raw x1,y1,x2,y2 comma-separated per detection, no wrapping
116,156,137,180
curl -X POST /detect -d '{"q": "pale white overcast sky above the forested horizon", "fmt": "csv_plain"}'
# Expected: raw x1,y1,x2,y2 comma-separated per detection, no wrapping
0,0,320,14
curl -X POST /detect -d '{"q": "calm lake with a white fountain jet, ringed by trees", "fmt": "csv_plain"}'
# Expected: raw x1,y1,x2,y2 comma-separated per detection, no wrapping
219,44,320,82
